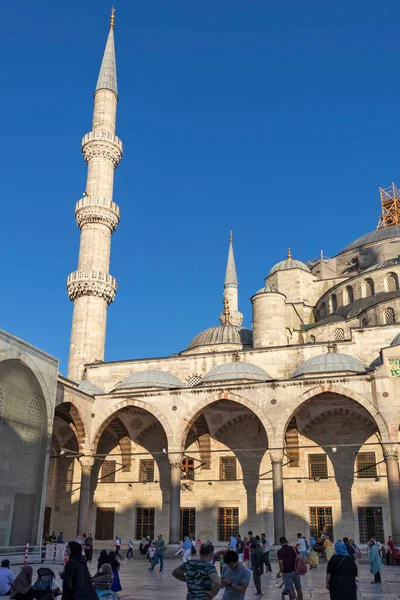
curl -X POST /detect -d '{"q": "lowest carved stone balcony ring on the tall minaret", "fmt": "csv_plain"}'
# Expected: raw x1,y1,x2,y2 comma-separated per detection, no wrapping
67,271,117,304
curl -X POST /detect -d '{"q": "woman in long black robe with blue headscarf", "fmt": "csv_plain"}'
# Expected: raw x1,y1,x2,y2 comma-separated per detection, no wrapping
326,541,357,600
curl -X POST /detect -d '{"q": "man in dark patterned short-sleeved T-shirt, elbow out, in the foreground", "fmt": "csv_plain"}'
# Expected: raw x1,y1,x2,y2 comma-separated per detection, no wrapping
172,542,221,600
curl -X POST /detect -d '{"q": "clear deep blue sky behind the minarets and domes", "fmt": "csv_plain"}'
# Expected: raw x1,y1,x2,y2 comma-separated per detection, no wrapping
0,0,400,373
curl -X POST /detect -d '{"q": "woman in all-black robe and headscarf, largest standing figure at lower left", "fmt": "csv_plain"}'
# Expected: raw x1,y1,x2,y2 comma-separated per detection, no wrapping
61,542,97,600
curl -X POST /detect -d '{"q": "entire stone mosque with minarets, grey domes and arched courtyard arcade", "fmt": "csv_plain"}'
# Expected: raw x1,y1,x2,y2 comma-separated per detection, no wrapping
0,15,400,546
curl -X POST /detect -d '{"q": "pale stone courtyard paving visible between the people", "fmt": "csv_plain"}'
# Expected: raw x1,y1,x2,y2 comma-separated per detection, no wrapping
9,558,400,600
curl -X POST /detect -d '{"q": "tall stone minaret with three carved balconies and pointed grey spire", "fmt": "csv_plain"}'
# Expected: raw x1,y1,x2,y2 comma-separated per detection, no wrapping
67,9,122,379
